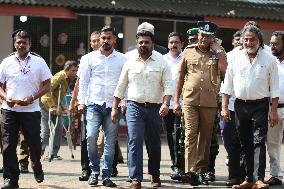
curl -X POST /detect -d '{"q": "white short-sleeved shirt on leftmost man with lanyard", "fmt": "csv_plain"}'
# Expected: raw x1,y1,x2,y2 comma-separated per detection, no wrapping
0,53,52,112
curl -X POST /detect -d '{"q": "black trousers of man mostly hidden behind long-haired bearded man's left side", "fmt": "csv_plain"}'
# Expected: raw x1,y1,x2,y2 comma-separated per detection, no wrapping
222,111,245,180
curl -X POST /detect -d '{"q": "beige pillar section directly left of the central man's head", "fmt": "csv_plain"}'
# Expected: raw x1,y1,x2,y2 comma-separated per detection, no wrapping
123,17,139,52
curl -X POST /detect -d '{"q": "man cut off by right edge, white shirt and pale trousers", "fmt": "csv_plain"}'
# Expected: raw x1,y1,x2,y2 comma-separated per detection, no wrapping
265,31,284,186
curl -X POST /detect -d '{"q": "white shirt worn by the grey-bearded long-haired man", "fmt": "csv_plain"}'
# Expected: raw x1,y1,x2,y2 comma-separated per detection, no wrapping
221,48,279,100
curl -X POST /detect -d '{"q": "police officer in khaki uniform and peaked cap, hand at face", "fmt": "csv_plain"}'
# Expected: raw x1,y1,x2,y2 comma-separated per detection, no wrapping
174,21,227,185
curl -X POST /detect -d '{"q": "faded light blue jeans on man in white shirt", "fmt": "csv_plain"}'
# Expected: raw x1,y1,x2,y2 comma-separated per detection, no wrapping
86,104,117,180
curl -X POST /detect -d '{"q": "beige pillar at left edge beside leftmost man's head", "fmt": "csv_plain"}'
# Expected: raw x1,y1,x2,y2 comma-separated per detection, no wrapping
0,16,14,60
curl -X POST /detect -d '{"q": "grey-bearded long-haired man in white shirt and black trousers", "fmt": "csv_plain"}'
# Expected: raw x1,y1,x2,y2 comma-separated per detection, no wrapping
221,25,279,188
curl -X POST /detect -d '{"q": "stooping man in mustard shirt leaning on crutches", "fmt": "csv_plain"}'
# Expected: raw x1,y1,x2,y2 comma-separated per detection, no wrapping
40,61,78,160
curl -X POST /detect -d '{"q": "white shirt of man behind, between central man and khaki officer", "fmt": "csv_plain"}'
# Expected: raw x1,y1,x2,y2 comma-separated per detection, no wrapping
163,52,183,109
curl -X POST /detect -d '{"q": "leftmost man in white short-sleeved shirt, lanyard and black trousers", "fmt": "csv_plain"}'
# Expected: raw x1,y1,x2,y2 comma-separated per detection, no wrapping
0,30,52,189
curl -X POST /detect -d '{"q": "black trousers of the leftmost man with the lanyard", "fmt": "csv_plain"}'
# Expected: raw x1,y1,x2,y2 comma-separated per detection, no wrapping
1,110,42,182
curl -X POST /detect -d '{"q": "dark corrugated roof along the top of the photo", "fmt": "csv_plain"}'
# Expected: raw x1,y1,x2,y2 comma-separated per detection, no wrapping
0,0,284,21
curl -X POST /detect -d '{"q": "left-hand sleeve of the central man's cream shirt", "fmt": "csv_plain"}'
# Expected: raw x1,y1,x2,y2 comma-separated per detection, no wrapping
114,62,128,99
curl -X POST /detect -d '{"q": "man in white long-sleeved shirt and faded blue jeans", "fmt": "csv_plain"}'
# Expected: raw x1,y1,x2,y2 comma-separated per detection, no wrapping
78,26,126,187
